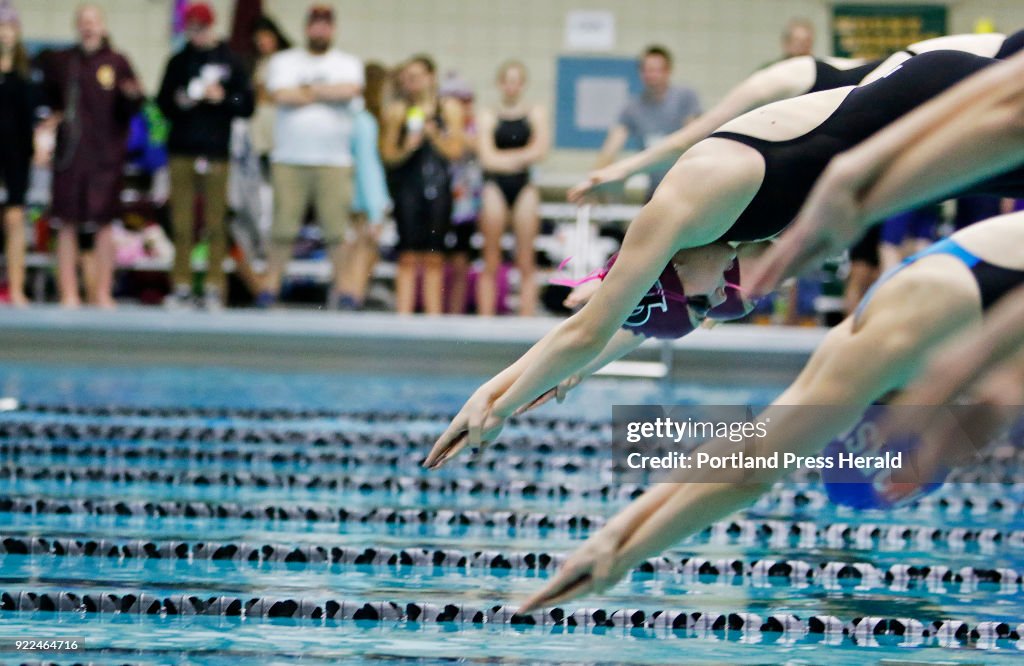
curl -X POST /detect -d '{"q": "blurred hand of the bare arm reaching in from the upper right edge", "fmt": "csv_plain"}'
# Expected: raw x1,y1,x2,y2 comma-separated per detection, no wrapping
743,162,867,298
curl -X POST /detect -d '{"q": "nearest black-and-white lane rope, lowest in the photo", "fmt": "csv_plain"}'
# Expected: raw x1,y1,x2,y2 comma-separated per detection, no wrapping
0,589,1024,649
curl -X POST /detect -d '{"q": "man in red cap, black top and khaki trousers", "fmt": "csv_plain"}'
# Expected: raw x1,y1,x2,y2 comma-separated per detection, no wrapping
157,2,253,310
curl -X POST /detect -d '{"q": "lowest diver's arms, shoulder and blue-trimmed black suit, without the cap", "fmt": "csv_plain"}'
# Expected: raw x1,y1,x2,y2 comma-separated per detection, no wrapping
520,213,1024,613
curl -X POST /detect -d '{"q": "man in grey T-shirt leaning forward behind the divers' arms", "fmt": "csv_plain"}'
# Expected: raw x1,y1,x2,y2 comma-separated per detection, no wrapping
596,45,700,199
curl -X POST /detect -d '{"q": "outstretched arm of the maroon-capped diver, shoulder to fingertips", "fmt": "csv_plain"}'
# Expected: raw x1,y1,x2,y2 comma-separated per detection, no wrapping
424,141,764,466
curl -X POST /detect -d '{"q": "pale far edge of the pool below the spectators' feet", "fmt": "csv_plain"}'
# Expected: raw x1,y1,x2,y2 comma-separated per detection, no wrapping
0,306,825,383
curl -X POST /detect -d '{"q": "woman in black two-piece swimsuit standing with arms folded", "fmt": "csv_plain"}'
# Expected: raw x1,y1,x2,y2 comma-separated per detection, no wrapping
476,61,550,316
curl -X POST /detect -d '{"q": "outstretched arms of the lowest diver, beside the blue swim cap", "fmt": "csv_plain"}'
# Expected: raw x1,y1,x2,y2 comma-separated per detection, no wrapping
522,272,976,612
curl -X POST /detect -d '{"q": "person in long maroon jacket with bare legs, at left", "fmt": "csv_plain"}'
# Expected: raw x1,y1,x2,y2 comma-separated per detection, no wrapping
44,4,142,307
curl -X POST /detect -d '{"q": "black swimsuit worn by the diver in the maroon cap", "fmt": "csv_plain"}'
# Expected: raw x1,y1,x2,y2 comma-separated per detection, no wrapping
712,51,1024,241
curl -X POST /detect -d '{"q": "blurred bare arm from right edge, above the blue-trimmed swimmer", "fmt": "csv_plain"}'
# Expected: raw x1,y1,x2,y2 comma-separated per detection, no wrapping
750,54,1024,294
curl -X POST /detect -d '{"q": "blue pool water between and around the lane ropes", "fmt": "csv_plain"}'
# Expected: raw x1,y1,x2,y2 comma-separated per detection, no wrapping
0,363,1024,665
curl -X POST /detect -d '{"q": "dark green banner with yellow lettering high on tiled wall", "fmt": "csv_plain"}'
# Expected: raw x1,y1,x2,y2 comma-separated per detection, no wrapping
833,4,946,58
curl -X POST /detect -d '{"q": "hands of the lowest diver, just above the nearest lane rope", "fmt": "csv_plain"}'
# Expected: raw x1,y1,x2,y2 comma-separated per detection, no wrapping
518,526,630,613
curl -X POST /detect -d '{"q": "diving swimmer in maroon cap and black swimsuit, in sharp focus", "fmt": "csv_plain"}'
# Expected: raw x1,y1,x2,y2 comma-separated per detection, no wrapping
424,51,1024,467
